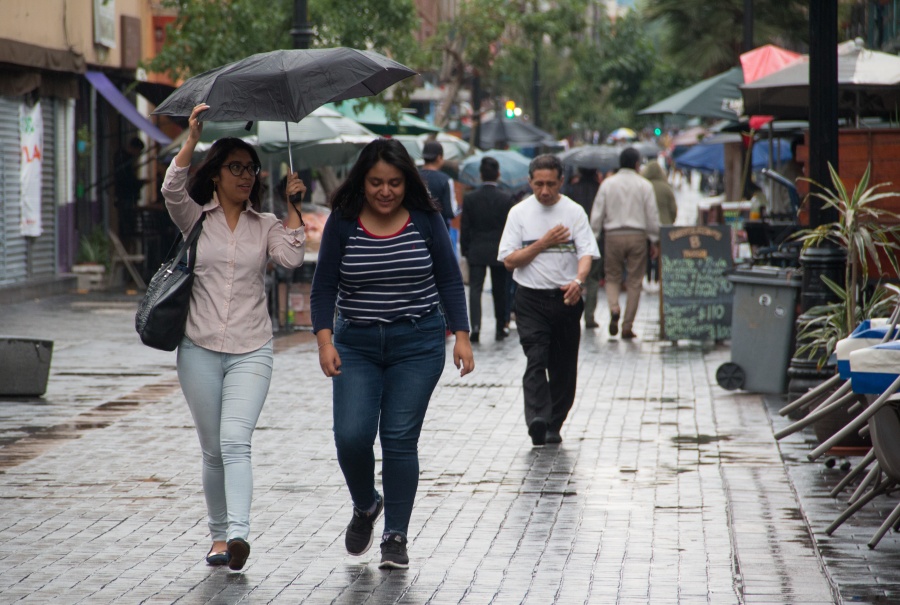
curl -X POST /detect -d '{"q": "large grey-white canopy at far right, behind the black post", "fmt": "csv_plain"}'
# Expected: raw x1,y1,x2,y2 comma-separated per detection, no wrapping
741,41,900,119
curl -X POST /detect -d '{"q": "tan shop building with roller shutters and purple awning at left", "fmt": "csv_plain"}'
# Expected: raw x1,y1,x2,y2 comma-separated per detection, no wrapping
0,0,170,301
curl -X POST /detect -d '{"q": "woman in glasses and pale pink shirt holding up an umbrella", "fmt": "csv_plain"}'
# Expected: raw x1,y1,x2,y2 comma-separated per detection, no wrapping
162,104,306,570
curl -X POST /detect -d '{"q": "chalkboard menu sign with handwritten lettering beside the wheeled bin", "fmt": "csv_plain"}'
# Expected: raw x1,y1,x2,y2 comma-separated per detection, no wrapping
659,226,734,341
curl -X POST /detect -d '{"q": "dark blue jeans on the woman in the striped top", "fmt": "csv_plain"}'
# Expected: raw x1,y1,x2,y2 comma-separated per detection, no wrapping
332,309,446,535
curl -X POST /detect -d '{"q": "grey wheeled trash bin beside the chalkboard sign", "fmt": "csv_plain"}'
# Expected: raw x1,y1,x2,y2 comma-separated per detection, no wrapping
716,266,802,393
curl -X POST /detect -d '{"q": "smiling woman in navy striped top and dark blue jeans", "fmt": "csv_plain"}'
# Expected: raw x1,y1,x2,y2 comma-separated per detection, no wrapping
310,139,475,569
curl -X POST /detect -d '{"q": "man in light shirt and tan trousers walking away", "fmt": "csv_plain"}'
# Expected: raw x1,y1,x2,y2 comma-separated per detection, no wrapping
591,147,659,339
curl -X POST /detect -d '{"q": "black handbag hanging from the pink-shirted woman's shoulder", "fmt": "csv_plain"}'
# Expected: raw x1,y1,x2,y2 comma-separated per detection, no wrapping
134,213,206,351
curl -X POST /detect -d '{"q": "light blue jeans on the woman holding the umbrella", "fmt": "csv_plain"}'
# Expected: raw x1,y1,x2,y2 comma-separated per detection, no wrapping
177,337,274,541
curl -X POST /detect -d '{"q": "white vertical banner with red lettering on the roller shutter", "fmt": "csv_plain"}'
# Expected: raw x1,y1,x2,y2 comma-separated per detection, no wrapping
19,101,44,237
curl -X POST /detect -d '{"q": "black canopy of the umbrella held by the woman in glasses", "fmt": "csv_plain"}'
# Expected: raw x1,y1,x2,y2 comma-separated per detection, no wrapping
153,48,416,122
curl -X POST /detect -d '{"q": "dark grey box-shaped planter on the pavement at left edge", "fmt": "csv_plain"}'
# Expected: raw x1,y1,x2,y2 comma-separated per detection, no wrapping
0,336,53,397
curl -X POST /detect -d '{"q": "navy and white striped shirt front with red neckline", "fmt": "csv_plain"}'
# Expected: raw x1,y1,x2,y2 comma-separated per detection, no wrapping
337,220,440,323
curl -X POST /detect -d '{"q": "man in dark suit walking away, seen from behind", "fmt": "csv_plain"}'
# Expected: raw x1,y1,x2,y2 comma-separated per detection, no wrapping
459,156,515,342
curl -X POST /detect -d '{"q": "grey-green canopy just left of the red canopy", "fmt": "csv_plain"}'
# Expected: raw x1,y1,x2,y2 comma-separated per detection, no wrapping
638,67,744,120
